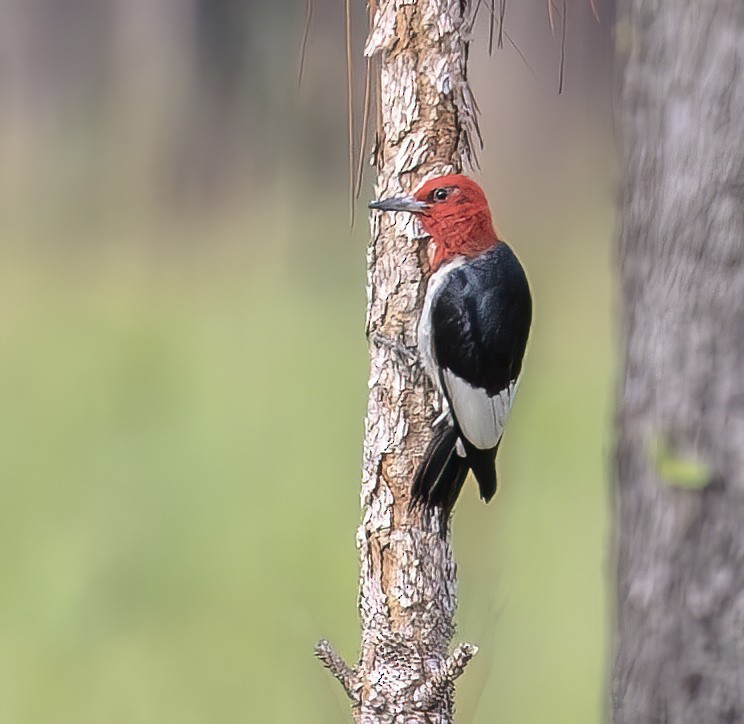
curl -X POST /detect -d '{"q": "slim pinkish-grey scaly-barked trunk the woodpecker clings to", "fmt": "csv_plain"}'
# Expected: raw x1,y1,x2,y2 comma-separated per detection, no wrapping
318,0,476,724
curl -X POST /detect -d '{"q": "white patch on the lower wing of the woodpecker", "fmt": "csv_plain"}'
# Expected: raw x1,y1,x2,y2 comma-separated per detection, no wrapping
443,369,519,450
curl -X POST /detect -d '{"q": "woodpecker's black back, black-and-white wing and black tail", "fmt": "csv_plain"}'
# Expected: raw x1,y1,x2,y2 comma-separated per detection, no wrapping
413,242,532,510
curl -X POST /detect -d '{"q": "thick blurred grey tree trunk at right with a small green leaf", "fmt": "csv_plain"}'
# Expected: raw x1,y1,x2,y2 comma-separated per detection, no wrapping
613,0,744,724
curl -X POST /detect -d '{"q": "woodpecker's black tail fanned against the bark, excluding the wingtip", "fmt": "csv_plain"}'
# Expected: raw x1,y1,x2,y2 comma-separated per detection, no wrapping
412,426,469,511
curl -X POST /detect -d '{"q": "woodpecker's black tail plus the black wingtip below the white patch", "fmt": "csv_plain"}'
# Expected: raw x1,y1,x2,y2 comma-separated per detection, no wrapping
412,426,499,512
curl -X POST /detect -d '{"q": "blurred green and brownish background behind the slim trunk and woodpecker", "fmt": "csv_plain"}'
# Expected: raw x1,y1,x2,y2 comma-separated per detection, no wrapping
0,0,615,724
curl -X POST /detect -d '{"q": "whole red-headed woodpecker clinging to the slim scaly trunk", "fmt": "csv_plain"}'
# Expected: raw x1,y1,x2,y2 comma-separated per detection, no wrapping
369,174,532,511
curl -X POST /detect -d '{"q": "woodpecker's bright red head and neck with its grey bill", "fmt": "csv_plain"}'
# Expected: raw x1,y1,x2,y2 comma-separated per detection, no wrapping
370,174,499,269
